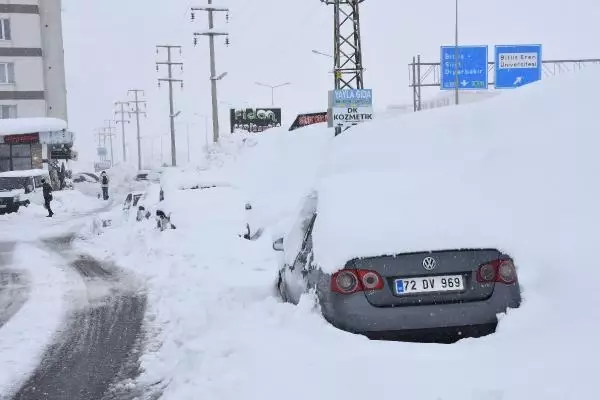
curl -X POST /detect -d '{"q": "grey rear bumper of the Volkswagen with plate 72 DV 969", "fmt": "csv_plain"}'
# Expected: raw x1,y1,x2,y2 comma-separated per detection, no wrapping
321,285,521,336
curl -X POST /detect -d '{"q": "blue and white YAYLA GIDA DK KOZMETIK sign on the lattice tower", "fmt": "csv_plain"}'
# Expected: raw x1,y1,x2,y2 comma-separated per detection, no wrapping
327,89,373,128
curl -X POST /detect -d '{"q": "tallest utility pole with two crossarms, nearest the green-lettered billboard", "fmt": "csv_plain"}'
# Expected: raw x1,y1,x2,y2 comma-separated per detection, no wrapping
192,0,229,143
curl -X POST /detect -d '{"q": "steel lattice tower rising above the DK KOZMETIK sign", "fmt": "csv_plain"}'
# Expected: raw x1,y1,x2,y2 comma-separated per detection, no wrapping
321,0,364,135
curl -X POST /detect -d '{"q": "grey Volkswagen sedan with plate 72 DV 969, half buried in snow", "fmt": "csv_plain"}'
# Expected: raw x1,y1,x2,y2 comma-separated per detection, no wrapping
273,193,521,341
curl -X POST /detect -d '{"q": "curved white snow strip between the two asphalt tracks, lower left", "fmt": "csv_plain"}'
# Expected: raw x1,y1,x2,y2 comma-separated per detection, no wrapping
0,245,71,397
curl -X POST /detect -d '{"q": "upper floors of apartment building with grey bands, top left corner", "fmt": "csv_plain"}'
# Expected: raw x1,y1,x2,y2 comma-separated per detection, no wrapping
0,0,67,121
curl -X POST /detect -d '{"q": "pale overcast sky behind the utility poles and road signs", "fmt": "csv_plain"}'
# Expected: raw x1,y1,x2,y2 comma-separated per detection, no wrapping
63,0,600,166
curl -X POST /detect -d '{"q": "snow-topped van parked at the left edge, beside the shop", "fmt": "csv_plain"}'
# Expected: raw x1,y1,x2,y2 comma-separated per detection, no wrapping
0,169,50,214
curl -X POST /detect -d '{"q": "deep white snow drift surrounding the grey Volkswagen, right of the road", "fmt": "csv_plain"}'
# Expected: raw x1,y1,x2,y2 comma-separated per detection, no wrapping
74,69,600,400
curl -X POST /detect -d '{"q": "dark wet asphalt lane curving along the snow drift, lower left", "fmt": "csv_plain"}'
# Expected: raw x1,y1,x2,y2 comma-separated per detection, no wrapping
0,237,160,400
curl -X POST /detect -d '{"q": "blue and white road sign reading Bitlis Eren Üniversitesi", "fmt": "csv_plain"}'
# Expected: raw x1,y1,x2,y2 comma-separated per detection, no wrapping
495,44,542,89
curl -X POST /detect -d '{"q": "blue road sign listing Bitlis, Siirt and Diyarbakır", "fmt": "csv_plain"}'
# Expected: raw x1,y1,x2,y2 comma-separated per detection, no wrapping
440,46,488,90
